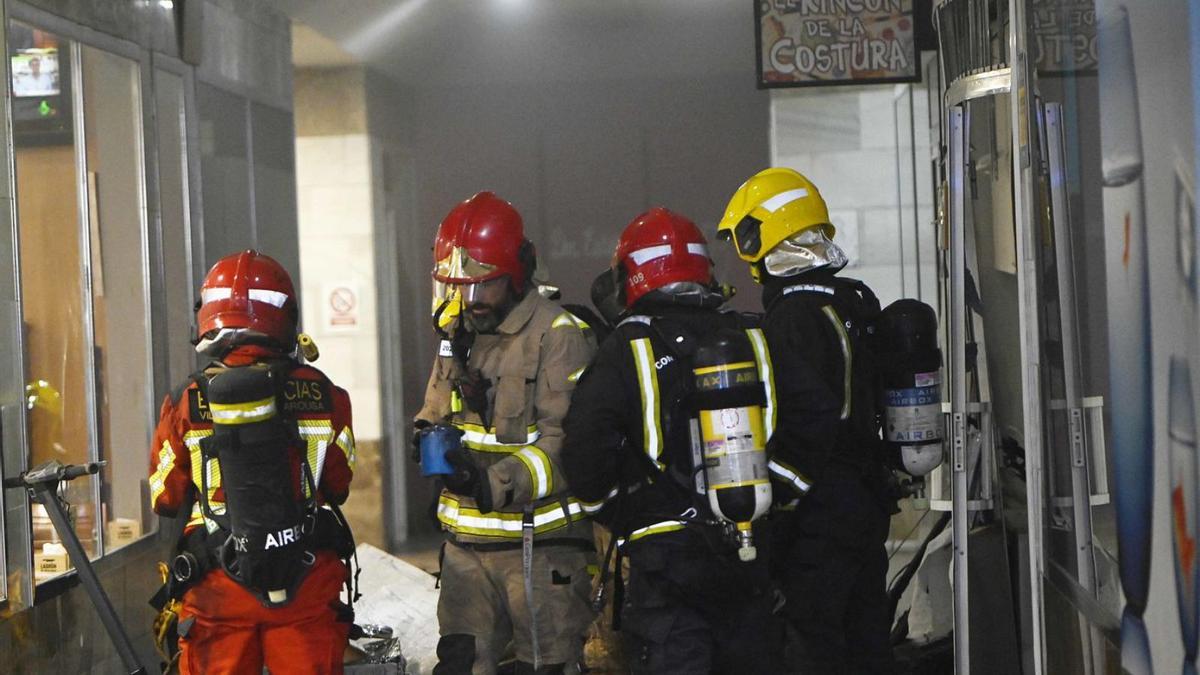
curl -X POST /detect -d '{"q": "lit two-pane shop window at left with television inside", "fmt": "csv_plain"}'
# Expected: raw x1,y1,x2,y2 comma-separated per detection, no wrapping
10,22,154,581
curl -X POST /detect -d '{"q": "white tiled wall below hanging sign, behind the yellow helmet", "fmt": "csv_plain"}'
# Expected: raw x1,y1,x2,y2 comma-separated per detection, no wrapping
770,75,936,305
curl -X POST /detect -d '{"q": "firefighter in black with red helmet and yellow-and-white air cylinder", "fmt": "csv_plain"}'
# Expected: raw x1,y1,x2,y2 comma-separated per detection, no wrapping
562,208,779,675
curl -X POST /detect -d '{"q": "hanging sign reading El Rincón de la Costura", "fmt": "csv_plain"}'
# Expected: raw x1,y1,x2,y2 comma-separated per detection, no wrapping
755,0,920,89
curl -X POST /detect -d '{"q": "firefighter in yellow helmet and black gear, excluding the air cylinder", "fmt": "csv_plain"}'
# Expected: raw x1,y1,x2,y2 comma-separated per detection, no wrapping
718,168,894,674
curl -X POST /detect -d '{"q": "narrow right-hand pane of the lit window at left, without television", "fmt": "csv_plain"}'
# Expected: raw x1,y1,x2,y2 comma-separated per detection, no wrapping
80,46,155,550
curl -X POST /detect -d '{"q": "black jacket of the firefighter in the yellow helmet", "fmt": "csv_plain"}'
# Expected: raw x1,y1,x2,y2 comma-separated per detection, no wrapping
763,270,883,501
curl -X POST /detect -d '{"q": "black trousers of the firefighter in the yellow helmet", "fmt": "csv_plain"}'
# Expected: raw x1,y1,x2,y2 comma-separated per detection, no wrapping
774,466,895,675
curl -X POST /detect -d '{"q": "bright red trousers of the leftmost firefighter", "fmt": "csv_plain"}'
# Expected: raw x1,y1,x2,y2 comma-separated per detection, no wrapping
179,551,350,675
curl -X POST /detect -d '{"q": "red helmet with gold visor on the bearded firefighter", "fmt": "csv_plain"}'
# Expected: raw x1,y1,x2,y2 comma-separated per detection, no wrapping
433,192,533,293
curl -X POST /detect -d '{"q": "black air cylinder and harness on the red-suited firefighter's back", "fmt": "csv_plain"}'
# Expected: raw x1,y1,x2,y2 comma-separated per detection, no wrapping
172,360,359,607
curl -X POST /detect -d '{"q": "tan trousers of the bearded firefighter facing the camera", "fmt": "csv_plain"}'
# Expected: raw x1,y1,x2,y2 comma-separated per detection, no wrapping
433,540,595,675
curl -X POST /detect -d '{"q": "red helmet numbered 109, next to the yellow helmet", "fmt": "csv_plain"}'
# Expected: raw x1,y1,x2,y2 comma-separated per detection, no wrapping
613,207,713,307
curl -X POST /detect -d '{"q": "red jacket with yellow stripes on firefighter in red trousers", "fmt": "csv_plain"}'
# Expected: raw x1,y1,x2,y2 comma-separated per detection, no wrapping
150,346,355,532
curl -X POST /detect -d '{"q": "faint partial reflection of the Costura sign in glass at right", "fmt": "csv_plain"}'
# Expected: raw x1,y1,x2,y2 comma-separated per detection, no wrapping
1030,0,1099,74
